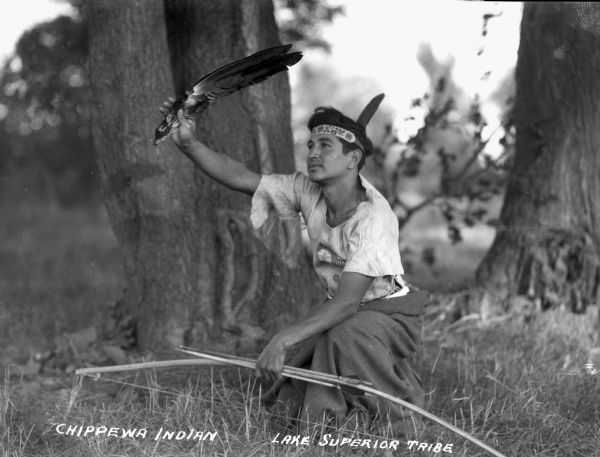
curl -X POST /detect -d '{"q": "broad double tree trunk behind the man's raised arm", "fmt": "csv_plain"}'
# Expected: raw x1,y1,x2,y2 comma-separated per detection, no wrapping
88,0,316,349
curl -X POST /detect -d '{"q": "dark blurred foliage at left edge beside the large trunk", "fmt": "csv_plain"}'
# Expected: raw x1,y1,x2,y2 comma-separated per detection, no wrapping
0,16,97,204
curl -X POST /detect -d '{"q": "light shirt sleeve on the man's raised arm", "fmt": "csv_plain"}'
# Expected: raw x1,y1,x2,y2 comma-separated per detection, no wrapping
250,172,308,229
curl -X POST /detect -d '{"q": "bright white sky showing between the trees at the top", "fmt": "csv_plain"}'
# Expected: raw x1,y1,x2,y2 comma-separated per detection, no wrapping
0,0,522,137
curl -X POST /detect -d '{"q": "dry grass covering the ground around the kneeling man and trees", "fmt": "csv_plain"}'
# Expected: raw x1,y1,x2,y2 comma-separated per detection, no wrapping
0,204,600,457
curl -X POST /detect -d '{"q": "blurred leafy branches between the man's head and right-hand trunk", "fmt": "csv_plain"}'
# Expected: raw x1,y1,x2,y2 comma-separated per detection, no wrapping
342,14,515,274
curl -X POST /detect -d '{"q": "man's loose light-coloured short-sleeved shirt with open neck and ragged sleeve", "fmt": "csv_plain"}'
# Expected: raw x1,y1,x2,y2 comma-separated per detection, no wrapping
250,172,405,303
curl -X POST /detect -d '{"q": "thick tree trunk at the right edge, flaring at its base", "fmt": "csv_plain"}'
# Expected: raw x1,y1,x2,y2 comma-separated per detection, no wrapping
478,2,600,312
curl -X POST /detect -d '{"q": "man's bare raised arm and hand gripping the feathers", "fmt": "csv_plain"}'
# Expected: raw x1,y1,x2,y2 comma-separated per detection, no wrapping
161,99,261,195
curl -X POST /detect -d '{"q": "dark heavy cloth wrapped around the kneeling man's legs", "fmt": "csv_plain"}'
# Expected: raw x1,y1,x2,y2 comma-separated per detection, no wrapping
267,292,426,434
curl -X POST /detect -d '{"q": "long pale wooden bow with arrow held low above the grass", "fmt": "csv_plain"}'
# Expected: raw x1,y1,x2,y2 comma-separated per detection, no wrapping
75,346,506,457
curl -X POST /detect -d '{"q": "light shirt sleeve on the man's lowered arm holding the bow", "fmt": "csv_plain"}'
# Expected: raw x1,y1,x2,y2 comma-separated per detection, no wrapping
344,208,404,277
